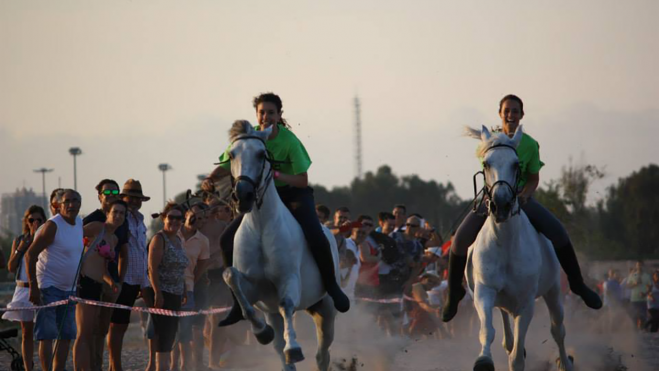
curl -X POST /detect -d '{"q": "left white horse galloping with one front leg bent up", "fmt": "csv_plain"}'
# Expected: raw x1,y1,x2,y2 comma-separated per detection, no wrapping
224,121,339,371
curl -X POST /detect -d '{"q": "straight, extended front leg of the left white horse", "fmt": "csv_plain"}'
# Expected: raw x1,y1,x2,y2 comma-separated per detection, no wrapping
278,275,304,364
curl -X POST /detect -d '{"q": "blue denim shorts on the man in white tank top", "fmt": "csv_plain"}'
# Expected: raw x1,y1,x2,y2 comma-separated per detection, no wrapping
34,286,77,340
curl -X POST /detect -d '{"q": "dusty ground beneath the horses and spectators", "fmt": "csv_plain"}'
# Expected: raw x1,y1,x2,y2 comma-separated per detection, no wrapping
0,309,659,371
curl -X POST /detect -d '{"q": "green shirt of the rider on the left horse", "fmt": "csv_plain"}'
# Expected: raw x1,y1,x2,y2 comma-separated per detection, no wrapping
220,124,311,187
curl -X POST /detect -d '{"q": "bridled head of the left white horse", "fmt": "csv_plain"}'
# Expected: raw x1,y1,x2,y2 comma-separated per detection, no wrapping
229,120,272,213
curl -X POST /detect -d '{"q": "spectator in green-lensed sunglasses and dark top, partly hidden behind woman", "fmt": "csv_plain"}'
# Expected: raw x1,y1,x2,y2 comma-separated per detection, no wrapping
82,179,128,371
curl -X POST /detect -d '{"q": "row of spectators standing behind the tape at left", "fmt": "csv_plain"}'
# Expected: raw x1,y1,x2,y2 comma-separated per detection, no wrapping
3,179,238,371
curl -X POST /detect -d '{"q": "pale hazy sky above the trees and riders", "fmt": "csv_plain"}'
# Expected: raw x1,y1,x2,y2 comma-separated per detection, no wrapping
0,0,659,218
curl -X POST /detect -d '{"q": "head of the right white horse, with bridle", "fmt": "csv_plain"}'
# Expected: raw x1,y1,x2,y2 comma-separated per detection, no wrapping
470,125,523,223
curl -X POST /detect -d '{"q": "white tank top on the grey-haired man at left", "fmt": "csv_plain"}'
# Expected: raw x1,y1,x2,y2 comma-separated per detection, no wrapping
37,214,83,291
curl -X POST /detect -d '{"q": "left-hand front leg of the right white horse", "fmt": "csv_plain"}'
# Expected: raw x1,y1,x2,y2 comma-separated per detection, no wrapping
474,283,497,371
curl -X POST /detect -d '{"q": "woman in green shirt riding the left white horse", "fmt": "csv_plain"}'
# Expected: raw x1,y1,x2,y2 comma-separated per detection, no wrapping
202,93,350,326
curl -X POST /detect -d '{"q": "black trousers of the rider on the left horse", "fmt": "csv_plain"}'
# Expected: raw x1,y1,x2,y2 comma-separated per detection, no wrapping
220,186,334,268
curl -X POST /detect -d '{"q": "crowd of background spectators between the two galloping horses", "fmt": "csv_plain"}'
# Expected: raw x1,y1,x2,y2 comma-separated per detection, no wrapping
316,204,450,336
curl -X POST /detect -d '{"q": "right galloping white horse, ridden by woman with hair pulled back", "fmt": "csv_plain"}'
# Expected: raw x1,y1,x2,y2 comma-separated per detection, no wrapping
466,126,572,371
